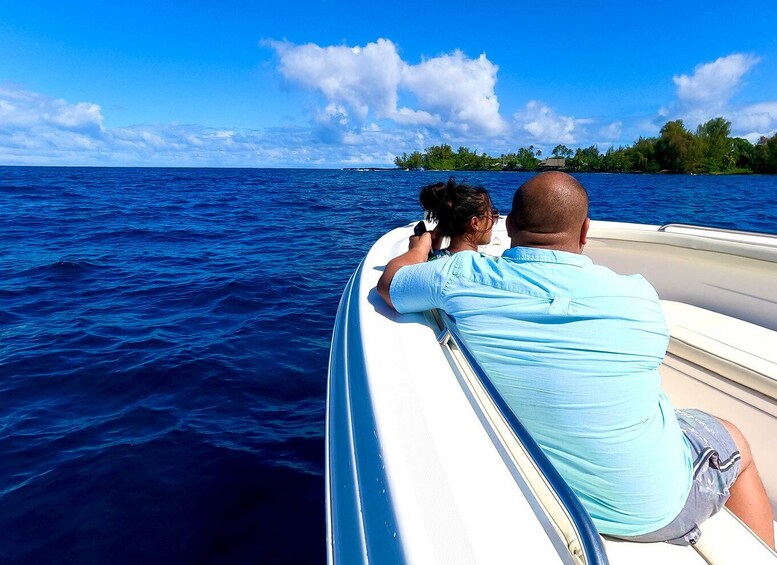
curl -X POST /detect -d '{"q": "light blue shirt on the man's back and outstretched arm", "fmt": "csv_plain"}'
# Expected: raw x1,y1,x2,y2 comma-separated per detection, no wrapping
390,247,692,536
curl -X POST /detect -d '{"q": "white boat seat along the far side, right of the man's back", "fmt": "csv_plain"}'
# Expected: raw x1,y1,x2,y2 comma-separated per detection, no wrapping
661,300,777,398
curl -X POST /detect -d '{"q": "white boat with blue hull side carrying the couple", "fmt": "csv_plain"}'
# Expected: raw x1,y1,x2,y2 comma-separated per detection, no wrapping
326,221,777,565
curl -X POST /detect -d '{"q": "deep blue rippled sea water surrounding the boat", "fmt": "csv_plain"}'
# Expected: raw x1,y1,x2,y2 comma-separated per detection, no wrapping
0,167,777,564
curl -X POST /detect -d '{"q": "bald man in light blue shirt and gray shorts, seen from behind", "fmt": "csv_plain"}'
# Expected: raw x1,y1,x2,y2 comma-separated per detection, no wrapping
378,172,774,547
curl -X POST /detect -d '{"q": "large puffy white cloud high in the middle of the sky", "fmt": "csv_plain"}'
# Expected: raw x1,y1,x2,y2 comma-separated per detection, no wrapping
267,39,505,136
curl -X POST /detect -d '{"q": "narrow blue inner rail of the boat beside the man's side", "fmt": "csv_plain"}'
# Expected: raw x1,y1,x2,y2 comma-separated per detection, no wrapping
434,310,608,565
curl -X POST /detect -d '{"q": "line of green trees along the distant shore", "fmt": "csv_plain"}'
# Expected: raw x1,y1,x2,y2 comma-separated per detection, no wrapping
394,118,777,174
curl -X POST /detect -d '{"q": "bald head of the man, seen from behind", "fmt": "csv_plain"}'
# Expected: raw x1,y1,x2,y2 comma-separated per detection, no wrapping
507,171,588,253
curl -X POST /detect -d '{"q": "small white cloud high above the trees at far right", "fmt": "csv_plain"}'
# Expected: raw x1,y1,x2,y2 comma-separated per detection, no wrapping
672,53,760,108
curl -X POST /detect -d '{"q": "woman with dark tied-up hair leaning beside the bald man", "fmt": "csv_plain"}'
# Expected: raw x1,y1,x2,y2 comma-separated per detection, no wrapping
418,178,499,259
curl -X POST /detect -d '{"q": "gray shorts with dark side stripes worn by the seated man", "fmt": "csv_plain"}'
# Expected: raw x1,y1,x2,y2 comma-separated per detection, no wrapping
622,410,740,545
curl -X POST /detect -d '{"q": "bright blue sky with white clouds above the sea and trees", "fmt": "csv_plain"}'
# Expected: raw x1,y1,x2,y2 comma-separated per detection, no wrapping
0,0,777,168
